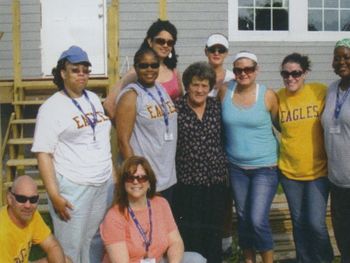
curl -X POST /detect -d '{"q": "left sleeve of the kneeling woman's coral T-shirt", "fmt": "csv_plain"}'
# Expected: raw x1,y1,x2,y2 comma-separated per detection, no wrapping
100,206,127,245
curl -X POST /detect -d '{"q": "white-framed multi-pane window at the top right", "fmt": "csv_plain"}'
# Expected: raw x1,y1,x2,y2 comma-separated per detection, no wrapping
228,0,350,41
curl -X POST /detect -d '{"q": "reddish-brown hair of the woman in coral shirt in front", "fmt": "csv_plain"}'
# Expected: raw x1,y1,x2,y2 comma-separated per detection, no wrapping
113,156,157,213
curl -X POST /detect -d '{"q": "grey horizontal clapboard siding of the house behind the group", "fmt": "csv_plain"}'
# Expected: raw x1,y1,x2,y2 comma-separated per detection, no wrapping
0,0,337,88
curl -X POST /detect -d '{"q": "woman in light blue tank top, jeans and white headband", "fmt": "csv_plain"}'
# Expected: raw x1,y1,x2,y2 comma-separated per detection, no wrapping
219,51,278,263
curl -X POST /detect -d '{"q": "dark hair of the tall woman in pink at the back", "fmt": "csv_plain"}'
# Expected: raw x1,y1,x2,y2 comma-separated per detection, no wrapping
140,19,177,69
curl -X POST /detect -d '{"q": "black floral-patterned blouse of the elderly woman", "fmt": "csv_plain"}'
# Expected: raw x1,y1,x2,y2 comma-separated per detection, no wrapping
176,95,228,186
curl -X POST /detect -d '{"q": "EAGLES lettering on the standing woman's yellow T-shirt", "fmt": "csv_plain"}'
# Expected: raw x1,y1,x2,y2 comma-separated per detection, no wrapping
279,105,320,123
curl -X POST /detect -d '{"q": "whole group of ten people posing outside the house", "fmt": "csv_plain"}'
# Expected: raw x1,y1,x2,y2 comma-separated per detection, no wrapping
0,20,350,263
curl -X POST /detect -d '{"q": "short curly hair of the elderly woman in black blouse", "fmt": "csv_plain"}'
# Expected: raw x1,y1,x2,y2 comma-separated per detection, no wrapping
182,61,216,91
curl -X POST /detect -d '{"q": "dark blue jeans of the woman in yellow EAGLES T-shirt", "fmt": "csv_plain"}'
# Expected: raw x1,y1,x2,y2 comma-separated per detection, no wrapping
281,175,333,263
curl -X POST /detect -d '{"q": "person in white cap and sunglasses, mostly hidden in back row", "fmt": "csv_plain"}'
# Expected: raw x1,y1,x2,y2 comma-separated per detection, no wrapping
204,33,235,97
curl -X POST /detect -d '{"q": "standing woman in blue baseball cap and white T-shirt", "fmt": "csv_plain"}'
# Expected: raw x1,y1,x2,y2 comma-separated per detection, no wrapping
32,46,113,263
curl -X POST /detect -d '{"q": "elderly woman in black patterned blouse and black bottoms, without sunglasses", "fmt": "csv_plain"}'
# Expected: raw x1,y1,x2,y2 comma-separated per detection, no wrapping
174,62,228,263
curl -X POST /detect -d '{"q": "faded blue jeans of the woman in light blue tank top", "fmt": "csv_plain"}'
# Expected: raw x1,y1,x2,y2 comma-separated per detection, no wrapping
229,164,278,252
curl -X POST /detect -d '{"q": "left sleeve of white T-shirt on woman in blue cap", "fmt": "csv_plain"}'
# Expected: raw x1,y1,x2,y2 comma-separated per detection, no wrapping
32,107,60,153
